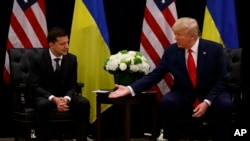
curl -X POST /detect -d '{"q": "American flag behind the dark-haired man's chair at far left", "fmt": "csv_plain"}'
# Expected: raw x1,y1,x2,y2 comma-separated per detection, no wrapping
3,0,47,84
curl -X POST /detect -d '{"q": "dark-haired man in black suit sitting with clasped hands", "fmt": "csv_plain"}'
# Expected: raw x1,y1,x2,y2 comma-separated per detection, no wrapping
30,27,90,141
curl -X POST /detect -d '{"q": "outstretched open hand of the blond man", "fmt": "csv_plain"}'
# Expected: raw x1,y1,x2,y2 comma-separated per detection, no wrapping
109,84,131,98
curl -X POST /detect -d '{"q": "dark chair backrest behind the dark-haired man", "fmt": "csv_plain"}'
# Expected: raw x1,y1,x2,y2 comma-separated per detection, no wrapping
9,48,47,108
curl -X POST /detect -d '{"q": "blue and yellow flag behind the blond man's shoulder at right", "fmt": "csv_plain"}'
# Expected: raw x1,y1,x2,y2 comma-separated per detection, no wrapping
202,0,239,48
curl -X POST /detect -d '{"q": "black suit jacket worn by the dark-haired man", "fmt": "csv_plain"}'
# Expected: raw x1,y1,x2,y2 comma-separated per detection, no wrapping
30,49,77,98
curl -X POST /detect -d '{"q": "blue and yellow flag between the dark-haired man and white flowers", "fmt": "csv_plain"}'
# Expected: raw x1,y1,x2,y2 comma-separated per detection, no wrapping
69,0,114,123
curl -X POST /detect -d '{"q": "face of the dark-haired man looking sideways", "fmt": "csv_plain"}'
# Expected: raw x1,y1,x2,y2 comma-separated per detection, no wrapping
49,36,69,57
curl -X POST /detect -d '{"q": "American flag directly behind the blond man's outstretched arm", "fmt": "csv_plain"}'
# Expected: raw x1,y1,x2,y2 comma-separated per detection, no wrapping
140,0,177,99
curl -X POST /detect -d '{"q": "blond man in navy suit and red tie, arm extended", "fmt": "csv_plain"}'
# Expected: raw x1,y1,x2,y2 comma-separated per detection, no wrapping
109,17,232,141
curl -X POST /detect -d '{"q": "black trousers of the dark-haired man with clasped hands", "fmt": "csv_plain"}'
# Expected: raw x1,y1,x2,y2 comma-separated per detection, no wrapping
35,96,90,141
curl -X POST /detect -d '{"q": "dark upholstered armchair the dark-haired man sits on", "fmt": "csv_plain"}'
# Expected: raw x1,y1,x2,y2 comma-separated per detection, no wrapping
9,48,83,141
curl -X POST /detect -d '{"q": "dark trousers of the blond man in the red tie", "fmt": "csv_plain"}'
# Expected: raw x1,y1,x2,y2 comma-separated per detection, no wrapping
160,92,233,141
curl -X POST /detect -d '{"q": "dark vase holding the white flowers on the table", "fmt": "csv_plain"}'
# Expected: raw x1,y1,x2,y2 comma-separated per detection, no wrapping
115,73,141,86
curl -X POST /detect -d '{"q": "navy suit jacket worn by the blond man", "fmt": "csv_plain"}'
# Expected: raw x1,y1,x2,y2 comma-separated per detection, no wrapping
131,39,227,102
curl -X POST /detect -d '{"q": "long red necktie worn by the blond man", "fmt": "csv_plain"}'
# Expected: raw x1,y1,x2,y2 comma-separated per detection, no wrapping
187,49,200,107
